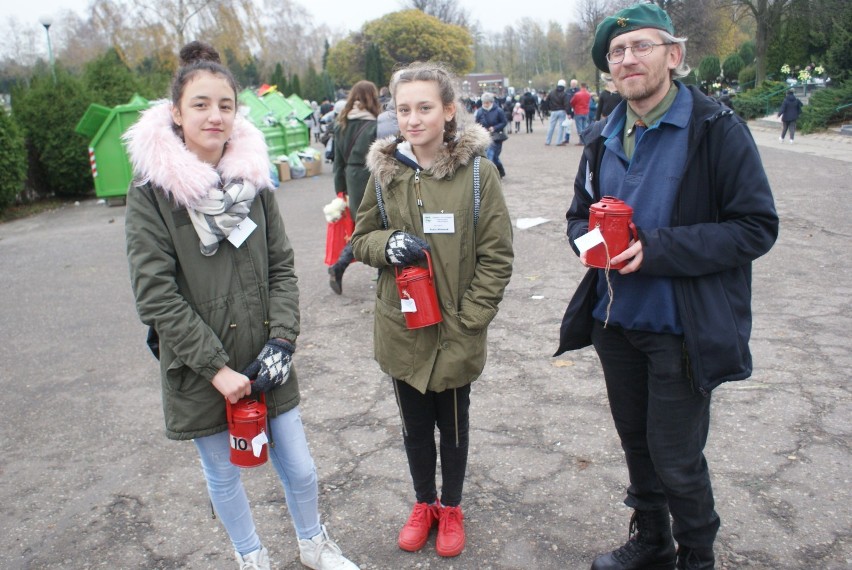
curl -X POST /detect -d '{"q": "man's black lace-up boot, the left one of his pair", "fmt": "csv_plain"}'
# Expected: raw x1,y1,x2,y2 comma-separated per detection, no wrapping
592,509,675,570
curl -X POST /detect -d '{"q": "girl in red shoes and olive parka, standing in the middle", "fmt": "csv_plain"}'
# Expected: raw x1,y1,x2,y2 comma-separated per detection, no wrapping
352,63,513,556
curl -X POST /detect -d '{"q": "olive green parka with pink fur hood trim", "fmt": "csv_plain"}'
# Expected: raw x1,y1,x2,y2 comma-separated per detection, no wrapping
125,105,299,439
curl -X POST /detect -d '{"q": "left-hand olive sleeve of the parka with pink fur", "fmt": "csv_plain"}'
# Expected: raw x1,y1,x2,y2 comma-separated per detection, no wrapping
125,187,229,380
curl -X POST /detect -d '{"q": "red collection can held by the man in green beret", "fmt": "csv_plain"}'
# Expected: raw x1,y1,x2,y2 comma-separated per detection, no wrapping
586,196,639,269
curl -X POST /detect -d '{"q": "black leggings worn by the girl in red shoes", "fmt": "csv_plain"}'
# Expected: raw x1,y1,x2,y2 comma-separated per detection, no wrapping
393,379,470,507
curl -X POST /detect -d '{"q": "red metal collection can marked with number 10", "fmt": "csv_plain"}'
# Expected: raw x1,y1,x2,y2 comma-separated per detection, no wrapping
225,394,269,467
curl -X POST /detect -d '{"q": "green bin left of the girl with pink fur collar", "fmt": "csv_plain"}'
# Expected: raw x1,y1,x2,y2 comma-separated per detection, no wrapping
74,95,150,203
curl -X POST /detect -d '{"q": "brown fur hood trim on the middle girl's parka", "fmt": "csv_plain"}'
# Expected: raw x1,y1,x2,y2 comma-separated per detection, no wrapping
367,123,491,188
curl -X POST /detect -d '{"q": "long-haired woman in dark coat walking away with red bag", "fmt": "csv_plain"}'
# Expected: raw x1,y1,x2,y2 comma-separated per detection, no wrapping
328,81,381,295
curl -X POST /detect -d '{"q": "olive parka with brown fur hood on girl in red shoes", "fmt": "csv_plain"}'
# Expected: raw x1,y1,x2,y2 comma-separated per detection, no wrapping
352,125,514,393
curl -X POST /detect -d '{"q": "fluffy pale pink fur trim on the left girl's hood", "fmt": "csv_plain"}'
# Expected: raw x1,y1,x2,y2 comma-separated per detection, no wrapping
122,101,273,209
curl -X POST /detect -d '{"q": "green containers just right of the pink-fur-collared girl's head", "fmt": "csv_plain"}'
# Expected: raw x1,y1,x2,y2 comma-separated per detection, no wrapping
238,89,310,160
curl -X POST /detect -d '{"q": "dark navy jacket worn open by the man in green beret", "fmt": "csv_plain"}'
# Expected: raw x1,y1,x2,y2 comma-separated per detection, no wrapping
556,85,778,395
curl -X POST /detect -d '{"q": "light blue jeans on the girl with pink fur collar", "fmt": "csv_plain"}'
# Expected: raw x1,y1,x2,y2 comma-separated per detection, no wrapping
194,407,321,556
